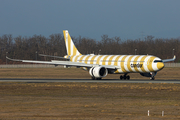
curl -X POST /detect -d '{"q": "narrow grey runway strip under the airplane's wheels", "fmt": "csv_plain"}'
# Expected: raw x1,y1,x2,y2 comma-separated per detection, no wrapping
0,78,180,84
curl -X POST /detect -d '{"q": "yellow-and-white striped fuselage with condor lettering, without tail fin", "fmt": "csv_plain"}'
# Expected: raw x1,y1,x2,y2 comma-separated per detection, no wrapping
67,55,164,73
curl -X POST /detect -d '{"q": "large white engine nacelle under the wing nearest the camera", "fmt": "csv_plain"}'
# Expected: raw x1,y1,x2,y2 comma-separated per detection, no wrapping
89,66,108,78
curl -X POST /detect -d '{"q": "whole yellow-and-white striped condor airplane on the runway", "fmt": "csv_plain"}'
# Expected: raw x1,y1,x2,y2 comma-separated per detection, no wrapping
6,30,176,80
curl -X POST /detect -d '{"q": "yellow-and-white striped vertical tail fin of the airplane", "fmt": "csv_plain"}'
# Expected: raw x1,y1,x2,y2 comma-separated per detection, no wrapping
63,30,81,55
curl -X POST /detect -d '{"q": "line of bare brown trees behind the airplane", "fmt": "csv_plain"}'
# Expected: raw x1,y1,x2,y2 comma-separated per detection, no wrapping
0,34,180,64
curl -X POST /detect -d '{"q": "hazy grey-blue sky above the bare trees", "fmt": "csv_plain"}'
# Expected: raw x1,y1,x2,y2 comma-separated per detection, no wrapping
0,0,180,40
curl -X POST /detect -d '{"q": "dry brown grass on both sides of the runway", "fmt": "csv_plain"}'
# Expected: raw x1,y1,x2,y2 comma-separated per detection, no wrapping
0,68,180,120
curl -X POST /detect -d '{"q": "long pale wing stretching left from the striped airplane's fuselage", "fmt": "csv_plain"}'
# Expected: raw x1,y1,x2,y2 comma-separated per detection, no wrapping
6,56,118,69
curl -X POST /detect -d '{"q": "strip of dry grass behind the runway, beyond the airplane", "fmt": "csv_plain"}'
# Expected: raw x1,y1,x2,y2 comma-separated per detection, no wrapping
0,68,180,80
